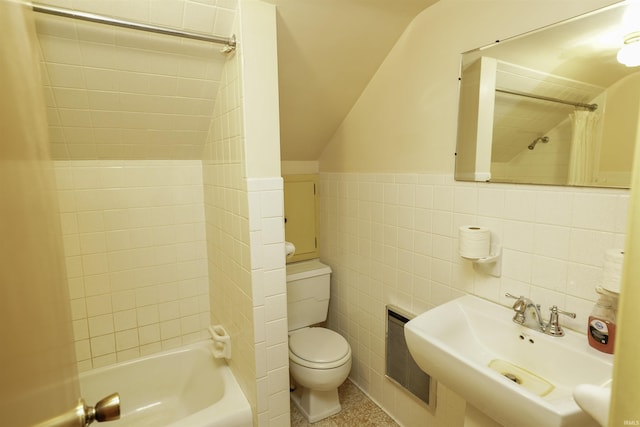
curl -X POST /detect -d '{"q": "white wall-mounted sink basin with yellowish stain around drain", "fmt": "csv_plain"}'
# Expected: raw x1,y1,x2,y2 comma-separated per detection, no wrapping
405,295,613,427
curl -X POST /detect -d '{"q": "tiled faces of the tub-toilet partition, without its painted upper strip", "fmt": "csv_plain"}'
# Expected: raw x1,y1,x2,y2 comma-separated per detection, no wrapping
203,30,289,426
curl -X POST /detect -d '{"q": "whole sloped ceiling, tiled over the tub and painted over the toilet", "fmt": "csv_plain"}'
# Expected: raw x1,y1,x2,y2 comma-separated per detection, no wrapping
36,0,437,160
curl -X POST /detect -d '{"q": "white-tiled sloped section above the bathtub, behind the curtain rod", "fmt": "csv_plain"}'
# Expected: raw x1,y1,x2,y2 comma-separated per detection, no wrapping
36,0,237,159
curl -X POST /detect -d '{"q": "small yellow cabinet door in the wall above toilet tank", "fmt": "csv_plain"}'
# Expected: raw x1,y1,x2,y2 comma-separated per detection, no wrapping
284,175,319,262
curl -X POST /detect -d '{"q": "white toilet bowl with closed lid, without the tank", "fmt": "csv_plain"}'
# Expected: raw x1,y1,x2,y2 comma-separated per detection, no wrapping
289,327,351,423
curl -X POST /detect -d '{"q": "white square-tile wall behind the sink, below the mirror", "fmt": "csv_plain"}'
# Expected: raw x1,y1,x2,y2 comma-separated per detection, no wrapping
320,173,629,427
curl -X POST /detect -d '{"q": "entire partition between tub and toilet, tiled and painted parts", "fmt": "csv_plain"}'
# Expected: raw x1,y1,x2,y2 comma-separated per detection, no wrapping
204,0,289,425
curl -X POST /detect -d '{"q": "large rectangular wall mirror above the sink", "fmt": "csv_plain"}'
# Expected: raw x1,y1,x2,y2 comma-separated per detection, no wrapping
455,2,640,188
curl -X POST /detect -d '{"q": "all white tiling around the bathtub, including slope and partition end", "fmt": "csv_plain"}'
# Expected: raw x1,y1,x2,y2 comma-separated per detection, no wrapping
38,0,289,426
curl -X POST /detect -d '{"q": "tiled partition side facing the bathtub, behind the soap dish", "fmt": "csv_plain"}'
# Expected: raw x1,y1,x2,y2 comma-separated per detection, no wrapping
203,24,258,424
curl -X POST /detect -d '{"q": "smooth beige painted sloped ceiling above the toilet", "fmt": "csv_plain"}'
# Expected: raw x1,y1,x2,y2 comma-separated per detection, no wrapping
266,0,437,160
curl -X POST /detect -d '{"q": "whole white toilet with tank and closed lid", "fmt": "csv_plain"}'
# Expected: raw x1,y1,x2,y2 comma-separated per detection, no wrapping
287,259,351,423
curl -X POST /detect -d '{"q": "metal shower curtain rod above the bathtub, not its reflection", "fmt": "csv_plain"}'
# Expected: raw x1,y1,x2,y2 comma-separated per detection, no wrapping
32,3,237,53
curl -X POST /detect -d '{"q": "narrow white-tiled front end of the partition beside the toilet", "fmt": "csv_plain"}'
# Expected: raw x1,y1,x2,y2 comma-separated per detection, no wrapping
247,177,289,426
